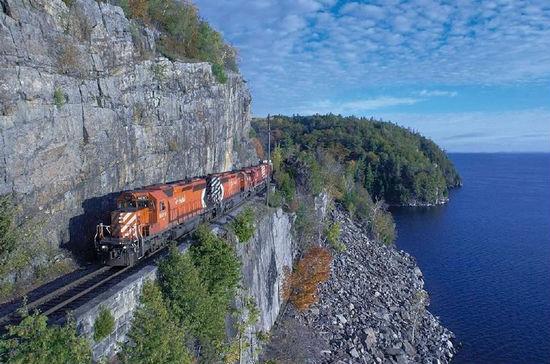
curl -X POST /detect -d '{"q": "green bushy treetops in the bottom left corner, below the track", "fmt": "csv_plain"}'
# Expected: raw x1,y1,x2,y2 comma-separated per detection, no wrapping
0,308,92,363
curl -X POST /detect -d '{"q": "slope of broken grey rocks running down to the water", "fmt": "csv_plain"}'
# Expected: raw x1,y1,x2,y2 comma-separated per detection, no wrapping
264,206,456,363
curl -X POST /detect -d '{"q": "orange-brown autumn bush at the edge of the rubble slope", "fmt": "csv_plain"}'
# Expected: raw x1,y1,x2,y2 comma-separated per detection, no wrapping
283,246,332,311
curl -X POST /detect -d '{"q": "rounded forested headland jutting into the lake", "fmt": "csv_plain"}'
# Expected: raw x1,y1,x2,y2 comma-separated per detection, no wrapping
253,114,461,205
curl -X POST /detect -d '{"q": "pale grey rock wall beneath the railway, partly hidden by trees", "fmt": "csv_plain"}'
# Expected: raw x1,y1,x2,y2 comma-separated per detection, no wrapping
74,201,294,363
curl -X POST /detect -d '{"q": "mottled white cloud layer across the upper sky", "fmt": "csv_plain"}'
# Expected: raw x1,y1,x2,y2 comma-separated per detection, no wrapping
196,0,550,118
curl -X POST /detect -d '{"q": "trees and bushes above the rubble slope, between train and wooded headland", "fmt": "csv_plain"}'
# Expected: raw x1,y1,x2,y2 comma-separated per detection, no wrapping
253,118,402,247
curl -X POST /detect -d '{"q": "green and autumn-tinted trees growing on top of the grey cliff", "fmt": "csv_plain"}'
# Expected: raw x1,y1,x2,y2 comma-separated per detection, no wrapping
109,0,237,83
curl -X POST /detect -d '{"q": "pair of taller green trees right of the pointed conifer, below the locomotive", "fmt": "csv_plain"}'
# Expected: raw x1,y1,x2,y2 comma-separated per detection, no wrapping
158,230,240,361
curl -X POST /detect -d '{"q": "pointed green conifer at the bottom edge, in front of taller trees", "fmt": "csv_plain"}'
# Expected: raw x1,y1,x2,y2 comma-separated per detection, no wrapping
121,281,193,363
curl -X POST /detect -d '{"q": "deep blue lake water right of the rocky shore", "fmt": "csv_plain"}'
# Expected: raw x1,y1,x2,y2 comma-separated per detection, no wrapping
393,154,550,363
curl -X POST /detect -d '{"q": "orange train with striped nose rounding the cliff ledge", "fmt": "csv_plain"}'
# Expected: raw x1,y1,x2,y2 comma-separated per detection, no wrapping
94,161,271,266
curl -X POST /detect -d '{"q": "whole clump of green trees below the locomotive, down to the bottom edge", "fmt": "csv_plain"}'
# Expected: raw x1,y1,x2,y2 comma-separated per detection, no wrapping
124,226,241,362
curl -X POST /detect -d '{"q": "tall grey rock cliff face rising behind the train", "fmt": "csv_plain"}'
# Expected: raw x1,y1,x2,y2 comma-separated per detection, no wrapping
0,0,257,258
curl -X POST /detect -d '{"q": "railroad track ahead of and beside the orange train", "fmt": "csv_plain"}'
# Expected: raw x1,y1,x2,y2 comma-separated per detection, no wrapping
0,193,268,331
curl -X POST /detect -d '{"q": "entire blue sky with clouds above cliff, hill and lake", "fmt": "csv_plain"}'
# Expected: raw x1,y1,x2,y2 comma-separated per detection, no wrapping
195,0,550,152
